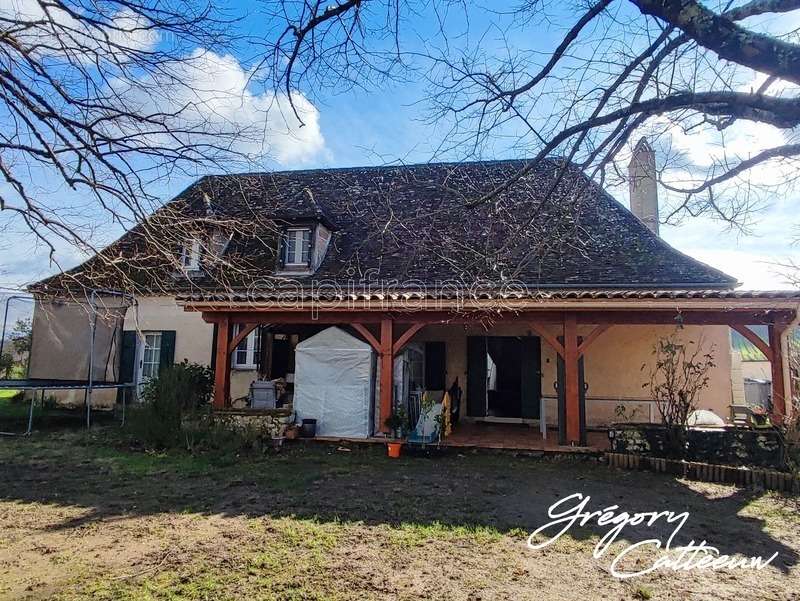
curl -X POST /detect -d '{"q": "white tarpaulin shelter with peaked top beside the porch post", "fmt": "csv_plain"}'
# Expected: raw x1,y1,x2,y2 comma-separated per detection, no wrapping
294,327,374,438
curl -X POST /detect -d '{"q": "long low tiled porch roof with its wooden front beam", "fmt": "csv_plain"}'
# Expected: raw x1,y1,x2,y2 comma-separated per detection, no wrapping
177,288,800,325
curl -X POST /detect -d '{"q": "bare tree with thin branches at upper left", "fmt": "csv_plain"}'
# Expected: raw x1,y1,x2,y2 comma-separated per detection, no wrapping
0,0,288,296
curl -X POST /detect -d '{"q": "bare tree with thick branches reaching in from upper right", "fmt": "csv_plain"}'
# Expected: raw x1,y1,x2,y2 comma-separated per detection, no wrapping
257,0,800,229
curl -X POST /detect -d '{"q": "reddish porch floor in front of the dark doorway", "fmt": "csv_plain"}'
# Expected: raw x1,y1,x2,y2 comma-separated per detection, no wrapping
442,422,609,453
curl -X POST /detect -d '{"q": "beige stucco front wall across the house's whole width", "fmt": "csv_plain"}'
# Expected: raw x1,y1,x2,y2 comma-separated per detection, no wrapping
31,297,744,425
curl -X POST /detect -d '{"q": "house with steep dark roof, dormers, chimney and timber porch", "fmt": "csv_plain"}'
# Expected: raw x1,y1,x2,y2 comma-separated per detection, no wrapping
26,140,800,444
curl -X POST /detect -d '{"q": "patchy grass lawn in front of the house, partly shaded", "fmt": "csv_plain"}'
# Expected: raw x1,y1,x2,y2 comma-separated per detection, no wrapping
0,429,800,601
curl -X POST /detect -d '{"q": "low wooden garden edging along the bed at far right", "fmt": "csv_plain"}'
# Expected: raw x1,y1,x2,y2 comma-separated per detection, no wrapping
605,453,800,493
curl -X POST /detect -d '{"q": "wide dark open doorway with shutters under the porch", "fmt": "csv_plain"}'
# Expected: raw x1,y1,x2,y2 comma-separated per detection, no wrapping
467,336,541,420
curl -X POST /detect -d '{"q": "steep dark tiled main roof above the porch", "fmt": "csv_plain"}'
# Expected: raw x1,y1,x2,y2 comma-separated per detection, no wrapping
34,160,736,296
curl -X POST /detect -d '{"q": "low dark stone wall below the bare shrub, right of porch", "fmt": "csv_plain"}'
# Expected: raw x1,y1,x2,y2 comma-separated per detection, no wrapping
609,425,786,469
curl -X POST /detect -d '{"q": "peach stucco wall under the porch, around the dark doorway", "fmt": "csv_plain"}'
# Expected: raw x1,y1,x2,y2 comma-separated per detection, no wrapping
413,325,732,425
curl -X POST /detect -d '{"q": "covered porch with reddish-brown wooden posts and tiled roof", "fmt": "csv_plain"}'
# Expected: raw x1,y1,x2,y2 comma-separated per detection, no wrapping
183,291,798,448
